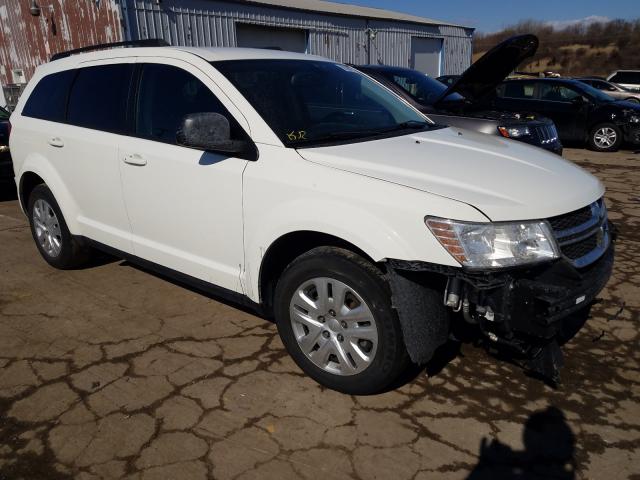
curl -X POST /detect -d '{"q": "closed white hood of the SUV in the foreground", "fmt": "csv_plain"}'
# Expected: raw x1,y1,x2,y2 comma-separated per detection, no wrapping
298,128,604,221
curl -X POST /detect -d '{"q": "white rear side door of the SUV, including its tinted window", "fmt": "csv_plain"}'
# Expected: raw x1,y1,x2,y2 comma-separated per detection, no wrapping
59,59,134,252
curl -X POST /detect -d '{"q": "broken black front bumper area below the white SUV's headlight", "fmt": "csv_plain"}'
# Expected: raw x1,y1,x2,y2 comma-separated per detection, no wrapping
387,242,614,380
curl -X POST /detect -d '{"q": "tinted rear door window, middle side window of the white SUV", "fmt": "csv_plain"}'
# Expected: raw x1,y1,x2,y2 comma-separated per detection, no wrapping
67,63,133,133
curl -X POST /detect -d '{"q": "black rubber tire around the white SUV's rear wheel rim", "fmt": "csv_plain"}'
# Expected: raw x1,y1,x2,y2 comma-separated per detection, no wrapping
27,184,91,270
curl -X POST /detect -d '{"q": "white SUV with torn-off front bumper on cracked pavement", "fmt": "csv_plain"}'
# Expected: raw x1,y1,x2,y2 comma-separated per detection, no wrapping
10,43,613,394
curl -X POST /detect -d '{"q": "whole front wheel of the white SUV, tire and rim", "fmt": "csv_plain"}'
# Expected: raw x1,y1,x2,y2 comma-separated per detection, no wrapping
274,247,411,395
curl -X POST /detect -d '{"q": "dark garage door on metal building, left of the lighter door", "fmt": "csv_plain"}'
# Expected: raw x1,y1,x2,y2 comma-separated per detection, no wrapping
236,23,307,53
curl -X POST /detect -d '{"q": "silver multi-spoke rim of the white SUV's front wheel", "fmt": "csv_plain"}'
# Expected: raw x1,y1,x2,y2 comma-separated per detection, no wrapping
289,277,378,375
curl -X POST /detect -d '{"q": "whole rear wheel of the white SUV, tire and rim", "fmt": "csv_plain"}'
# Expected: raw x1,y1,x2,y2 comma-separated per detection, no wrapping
28,184,90,269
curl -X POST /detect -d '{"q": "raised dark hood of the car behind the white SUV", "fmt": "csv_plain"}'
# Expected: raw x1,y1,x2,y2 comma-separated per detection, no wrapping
435,35,538,105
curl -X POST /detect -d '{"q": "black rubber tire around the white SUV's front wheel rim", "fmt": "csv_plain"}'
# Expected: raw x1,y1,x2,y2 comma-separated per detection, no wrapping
274,247,412,395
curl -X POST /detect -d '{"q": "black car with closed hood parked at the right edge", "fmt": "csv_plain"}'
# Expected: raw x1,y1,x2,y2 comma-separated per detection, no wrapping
490,78,640,152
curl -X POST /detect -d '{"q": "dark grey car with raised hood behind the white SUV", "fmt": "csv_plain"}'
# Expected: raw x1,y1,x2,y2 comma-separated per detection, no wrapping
355,35,562,154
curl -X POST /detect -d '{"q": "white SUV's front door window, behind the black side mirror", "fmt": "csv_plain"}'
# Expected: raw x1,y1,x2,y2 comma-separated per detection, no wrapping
135,63,246,144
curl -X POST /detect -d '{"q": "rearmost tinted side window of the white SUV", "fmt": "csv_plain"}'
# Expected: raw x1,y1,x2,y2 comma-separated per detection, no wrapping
22,70,76,122
